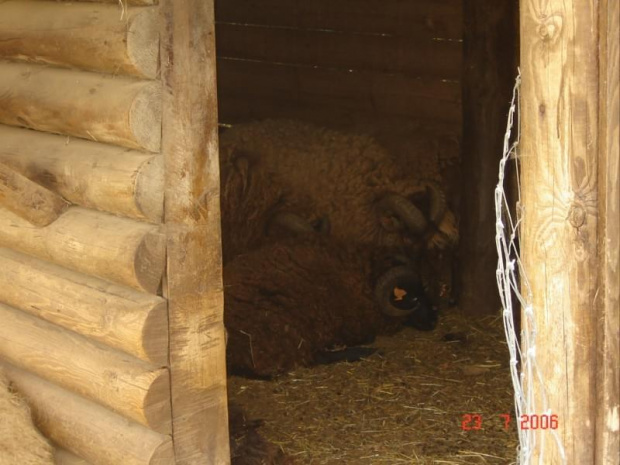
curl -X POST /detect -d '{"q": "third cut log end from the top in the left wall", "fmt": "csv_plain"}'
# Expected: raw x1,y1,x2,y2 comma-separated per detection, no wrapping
136,155,164,223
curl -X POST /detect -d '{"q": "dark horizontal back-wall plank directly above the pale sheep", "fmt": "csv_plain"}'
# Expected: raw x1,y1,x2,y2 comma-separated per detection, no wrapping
218,59,461,123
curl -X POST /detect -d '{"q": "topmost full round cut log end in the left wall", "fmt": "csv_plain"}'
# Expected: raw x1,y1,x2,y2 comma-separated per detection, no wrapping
127,9,159,79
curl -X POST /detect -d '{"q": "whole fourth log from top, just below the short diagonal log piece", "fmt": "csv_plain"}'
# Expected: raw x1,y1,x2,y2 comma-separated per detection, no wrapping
0,207,165,294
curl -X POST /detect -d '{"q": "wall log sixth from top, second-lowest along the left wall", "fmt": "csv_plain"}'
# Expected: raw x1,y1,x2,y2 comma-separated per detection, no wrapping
0,304,171,434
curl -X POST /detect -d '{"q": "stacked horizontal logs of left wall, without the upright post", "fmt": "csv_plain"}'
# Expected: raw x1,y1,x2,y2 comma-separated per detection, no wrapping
0,0,184,465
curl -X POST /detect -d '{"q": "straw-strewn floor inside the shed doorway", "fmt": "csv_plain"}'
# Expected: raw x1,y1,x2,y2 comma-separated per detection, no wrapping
229,309,518,465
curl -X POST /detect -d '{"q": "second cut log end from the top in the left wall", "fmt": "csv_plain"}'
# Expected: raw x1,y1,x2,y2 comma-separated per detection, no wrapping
129,82,162,152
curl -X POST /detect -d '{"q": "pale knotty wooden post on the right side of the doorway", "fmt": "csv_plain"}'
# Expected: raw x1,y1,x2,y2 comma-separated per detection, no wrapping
521,0,618,464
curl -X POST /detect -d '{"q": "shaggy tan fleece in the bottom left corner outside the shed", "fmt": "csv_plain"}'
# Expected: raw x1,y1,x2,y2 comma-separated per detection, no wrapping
0,368,54,465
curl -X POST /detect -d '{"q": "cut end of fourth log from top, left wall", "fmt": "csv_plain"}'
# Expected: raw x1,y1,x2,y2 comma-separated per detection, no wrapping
134,230,166,294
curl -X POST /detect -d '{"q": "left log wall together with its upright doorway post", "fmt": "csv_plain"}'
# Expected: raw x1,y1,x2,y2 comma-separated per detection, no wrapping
0,0,229,465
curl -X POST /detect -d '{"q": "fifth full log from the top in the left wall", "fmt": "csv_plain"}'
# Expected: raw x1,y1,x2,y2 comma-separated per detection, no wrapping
0,248,168,366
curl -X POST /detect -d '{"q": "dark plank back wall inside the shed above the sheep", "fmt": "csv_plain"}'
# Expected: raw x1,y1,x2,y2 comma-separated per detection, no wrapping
215,0,463,128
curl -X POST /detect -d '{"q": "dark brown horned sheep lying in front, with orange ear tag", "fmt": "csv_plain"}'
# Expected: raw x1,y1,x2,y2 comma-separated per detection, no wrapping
224,237,436,377
